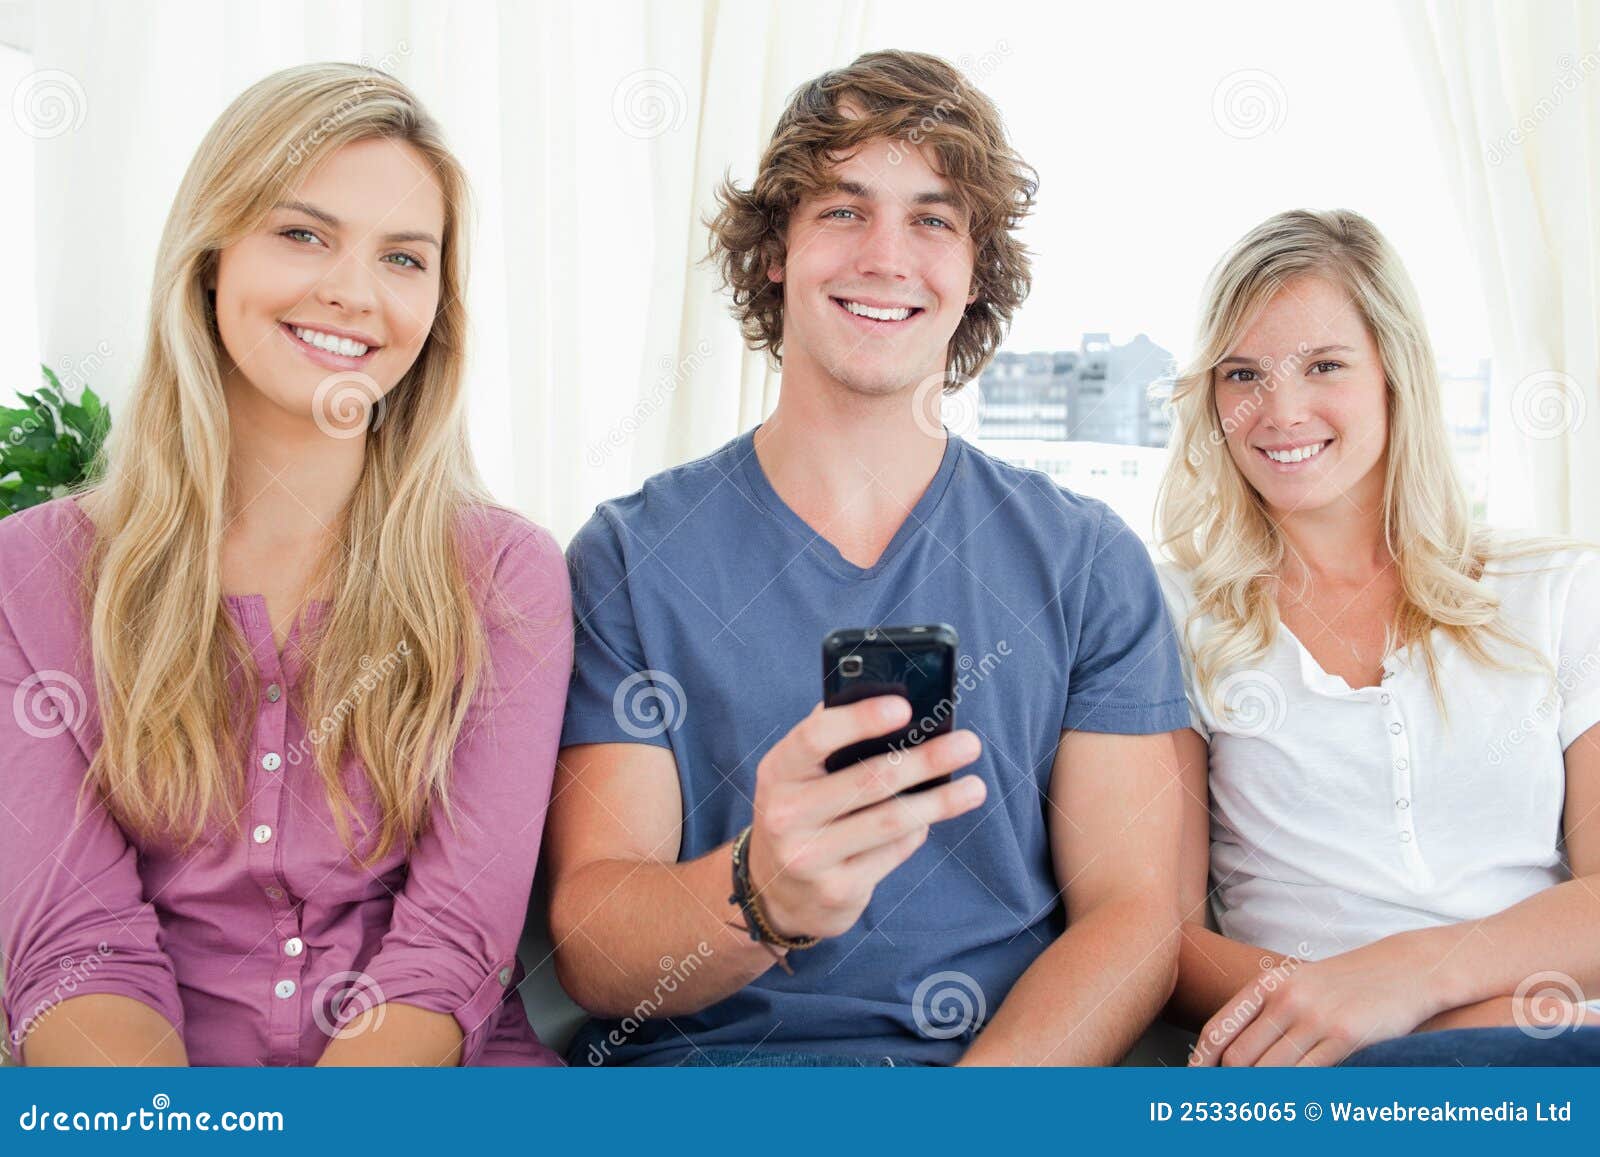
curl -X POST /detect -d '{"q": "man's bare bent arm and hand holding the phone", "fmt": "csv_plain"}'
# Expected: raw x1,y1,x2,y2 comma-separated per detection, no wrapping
546,696,986,1016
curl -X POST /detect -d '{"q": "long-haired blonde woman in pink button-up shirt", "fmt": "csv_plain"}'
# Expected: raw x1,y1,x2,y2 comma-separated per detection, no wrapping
0,64,571,1064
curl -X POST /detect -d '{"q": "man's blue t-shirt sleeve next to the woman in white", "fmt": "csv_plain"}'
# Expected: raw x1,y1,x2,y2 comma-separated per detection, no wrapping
1061,507,1189,735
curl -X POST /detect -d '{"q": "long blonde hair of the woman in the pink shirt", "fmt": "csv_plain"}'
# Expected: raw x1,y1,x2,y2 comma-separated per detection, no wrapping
76,64,512,859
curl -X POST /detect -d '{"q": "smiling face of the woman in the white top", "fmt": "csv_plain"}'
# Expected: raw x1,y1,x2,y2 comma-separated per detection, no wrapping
1211,275,1389,520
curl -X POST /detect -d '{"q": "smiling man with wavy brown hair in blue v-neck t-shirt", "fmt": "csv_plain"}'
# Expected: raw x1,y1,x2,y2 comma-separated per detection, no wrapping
547,53,1189,1064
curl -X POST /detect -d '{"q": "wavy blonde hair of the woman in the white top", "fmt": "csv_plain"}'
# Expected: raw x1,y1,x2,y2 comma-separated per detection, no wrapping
1157,210,1563,711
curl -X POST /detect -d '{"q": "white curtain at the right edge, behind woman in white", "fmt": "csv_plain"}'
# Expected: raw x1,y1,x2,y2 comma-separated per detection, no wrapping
1395,0,1600,539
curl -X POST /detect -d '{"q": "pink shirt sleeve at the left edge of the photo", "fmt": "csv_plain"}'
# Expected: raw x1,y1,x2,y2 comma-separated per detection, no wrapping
0,607,184,1053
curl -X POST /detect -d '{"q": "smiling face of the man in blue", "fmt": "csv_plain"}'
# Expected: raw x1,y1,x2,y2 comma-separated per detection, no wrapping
768,138,978,397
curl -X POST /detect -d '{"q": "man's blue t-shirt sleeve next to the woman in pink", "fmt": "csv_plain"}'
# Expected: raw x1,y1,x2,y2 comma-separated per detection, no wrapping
562,512,672,747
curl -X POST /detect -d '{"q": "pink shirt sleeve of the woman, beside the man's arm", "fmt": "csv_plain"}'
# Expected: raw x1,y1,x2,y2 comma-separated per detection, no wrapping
356,530,573,1064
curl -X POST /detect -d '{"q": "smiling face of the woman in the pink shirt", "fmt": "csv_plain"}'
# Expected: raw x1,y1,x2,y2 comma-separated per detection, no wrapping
211,139,445,426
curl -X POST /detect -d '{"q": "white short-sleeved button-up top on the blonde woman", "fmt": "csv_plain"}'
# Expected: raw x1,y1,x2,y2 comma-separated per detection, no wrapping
1160,550,1600,960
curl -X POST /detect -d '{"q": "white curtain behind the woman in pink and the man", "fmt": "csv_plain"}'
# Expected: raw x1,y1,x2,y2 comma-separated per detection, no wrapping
30,0,866,541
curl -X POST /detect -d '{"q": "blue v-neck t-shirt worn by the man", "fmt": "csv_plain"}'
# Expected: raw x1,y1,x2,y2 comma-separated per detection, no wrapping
562,430,1189,1064
